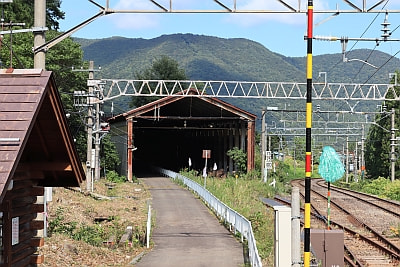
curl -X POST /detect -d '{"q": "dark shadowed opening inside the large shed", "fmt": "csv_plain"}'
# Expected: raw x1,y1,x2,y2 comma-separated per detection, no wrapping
133,122,239,171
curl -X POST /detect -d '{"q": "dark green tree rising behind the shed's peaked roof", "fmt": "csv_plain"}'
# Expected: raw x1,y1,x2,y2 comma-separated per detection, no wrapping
129,55,187,107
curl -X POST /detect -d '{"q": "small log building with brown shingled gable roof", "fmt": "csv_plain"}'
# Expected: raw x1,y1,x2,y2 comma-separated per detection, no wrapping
0,69,85,266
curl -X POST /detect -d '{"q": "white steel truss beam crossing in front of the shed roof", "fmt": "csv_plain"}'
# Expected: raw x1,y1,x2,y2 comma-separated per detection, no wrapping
88,79,400,102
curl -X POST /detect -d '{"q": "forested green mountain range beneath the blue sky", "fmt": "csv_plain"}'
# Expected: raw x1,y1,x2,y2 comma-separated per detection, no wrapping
75,34,400,118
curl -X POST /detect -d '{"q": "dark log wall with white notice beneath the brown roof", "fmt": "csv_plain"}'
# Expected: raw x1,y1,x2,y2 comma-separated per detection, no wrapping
0,175,44,267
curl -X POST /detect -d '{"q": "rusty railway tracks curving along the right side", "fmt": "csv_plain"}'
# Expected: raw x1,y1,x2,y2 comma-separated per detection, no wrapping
276,179,400,266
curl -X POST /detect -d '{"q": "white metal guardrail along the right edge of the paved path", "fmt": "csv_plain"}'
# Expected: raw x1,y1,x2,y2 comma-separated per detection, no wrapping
155,168,262,267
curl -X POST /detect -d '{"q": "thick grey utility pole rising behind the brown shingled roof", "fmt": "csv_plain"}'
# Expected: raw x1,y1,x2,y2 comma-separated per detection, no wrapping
33,0,46,69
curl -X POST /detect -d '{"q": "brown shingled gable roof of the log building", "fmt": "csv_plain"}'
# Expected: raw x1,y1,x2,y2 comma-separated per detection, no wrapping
0,69,85,201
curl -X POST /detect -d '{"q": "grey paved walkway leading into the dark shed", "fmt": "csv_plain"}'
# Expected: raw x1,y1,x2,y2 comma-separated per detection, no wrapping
136,177,244,267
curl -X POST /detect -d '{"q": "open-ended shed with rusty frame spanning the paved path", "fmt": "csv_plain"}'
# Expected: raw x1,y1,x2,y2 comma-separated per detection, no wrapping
109,90,256,180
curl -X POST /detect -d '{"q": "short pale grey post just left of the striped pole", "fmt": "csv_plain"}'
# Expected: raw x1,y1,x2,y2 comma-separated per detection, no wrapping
292,187,301,267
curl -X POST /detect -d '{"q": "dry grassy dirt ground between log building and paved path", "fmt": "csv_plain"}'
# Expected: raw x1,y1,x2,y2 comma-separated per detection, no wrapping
40,180,150,267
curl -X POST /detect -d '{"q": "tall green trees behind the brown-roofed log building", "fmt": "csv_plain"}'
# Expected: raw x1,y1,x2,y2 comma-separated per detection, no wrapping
0,0,87,162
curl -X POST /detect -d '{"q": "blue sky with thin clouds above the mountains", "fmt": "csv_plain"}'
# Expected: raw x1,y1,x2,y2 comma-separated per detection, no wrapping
60,0,400,57
